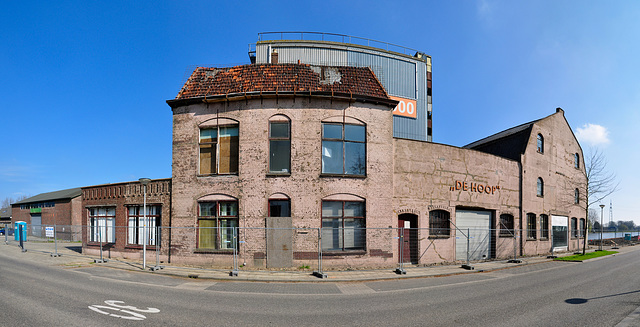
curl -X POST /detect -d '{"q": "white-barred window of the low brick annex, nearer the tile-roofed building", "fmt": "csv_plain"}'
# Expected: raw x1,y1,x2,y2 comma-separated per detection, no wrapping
127,205,162,245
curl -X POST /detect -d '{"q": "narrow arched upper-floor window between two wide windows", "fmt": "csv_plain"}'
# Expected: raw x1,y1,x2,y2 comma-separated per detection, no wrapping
269,115,291,174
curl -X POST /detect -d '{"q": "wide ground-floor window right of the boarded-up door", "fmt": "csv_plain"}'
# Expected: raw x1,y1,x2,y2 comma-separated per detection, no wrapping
322,200,366,251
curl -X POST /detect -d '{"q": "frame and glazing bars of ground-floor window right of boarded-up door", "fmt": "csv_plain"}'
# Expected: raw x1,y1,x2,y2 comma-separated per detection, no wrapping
320,200,367,253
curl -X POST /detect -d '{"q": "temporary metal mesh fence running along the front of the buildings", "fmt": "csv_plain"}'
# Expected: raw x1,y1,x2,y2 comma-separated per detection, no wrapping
4,220,639,277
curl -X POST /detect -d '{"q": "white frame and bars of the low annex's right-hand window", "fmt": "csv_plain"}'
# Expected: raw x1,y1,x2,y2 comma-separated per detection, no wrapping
126,204,162,246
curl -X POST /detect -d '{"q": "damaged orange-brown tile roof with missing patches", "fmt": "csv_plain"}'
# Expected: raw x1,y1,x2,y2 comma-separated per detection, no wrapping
175,64,389,100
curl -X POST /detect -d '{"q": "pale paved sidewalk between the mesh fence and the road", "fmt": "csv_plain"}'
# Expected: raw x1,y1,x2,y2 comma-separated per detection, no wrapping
0,241,637,282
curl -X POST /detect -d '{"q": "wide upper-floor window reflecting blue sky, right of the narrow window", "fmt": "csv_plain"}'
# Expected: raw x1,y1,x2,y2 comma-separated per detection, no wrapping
322,122,367,176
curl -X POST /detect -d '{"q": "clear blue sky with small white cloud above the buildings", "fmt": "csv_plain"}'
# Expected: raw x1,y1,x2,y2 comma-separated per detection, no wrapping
0,0,640,224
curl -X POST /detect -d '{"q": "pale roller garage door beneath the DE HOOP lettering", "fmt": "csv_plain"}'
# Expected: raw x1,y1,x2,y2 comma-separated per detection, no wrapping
455,210,491,260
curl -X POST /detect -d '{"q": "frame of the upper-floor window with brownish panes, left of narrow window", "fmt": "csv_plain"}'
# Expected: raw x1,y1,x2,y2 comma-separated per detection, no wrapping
198,123,240,176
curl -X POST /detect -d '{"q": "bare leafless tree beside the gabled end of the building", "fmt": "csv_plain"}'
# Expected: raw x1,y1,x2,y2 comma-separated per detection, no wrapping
578,149,620,254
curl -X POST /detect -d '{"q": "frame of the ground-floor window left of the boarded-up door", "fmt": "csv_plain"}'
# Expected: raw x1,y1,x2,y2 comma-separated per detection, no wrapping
196,200,240,252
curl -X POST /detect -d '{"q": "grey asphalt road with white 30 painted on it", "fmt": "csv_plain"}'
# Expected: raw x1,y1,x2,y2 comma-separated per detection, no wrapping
0,250,640,326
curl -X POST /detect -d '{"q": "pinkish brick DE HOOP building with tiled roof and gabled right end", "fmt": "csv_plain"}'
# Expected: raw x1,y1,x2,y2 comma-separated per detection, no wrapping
167,64,585,268
